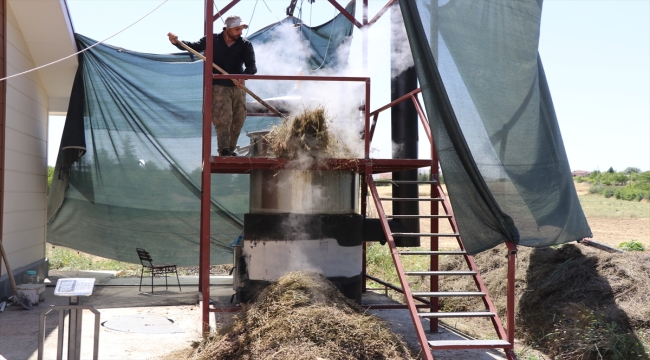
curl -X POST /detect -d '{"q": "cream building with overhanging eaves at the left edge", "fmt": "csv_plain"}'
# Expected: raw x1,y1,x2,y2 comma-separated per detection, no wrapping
0,0,78,299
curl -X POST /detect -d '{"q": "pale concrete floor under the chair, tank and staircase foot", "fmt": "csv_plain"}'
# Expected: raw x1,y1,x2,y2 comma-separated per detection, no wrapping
0,271,505,360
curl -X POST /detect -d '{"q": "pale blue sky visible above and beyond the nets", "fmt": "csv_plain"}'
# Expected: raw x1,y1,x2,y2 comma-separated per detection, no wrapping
48,0,650,170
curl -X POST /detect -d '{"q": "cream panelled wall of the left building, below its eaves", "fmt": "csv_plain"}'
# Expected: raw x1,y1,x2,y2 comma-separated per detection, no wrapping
2,4,48,269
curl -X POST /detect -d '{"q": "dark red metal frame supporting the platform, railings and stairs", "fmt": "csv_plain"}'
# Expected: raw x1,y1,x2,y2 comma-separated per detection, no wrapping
199,0,517,359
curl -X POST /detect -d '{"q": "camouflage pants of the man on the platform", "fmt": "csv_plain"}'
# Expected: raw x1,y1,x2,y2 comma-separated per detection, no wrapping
212,85,246,153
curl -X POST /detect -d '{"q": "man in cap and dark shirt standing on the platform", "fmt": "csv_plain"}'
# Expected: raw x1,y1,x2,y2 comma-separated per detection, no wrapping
167,16,257,156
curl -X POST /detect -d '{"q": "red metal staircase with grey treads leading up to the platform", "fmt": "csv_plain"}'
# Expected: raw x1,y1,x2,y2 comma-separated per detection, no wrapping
365,174,516,359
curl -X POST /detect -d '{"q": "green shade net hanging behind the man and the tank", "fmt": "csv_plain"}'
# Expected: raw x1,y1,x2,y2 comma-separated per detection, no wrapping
47,7,354,266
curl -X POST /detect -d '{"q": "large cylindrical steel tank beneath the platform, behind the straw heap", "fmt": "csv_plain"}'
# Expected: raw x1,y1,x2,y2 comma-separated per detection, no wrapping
235,134,363,302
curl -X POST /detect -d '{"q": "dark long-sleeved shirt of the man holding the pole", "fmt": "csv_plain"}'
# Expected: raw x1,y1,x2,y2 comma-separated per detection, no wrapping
176,33,257,86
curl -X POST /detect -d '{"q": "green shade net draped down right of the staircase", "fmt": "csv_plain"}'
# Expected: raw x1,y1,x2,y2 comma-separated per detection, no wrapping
399,0,591,254
